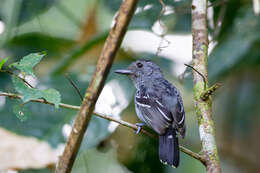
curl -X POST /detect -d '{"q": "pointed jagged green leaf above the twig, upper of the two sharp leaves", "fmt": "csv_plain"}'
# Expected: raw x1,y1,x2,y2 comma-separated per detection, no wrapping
10,53,45,76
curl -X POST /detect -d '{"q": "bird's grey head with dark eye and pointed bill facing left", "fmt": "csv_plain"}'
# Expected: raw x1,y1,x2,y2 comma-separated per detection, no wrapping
115,60,163,89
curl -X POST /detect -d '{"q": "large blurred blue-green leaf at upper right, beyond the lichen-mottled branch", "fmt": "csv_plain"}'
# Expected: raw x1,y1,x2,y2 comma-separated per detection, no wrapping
209,8,260,80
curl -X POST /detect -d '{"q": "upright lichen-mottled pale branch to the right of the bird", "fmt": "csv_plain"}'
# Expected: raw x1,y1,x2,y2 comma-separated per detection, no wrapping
192,0,221,173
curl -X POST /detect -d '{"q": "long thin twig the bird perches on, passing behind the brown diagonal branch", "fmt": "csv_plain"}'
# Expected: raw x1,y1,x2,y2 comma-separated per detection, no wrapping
0,91,206,164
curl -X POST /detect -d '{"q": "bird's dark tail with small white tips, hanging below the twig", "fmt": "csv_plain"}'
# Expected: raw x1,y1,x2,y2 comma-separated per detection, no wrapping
159,128,180,168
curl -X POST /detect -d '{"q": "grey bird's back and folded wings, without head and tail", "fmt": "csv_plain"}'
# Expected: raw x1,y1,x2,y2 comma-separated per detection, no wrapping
135,78,185,136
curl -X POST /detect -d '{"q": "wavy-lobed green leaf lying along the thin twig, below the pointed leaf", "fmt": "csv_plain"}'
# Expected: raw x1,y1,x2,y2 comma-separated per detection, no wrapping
12,76,61,108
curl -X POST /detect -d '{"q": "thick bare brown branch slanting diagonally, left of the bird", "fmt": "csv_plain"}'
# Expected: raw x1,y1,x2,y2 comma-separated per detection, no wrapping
56,0,138,173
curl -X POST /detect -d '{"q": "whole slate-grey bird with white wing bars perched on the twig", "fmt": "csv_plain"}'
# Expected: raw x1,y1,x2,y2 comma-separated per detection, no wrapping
115,60,185,167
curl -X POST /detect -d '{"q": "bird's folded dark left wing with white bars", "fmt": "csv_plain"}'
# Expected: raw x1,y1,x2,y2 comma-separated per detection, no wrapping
135,93,173,135
